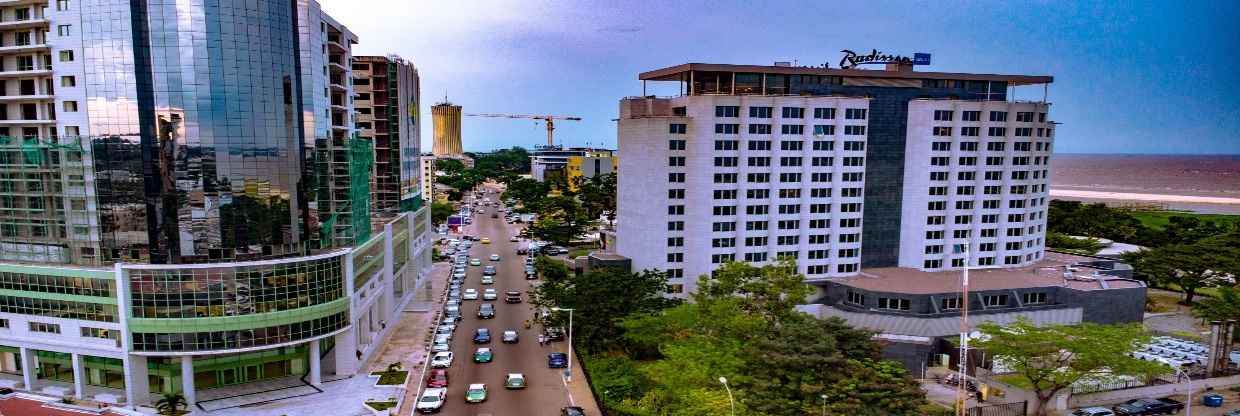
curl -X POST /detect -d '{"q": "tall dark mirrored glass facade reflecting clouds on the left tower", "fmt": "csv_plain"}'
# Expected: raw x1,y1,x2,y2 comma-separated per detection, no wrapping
81,0,305,263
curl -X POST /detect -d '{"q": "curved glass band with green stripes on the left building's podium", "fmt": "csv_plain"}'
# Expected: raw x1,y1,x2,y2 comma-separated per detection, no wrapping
129,256,345,318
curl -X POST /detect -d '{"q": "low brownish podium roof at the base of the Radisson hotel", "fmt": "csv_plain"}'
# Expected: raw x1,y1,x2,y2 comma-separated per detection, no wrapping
832,251,1142,294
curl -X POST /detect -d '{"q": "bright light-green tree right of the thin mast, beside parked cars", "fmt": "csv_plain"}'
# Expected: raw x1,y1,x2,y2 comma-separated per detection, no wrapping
973,318,1171,415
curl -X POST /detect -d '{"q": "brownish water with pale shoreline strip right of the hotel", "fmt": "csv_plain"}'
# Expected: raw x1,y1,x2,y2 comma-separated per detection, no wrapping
1050,153,1240,215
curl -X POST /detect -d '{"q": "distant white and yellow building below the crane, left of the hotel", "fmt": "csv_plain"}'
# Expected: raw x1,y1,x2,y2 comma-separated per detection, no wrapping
529,145,620,189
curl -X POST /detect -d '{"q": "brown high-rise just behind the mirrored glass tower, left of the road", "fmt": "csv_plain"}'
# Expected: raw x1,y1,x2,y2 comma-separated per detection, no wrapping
353,56,421,217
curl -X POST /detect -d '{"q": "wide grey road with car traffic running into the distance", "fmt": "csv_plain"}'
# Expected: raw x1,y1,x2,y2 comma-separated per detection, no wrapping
419,189,594,416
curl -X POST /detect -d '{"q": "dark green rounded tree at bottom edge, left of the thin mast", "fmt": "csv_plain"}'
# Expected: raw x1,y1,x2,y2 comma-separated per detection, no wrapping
737,314,925,415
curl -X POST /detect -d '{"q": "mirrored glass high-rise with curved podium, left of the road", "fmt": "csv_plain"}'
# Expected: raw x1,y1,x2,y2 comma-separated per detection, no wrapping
0,0,430,406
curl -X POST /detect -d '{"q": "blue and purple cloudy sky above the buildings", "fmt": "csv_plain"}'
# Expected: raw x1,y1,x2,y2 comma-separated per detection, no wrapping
319,0,1240,154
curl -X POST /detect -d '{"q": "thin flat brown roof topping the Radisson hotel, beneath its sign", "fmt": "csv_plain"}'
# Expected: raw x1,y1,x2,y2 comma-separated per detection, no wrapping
637,62,1055,86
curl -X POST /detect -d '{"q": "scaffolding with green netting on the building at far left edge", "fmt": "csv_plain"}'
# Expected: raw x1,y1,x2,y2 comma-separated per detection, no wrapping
0,137,100,265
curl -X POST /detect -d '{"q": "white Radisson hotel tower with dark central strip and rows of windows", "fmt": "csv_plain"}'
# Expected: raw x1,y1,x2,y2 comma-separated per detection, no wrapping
616,63,1055,296
